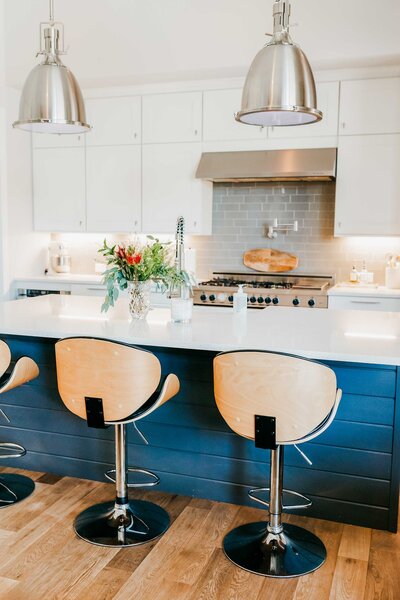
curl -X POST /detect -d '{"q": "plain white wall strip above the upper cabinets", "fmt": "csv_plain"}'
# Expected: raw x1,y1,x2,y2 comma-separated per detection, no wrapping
6,0,400,87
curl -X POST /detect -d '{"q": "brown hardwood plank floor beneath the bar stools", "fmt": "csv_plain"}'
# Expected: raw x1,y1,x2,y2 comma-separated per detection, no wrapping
0,469,400,600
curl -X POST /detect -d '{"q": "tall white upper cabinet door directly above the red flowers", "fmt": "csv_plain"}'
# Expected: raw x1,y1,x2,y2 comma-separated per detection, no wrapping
86,146,141,233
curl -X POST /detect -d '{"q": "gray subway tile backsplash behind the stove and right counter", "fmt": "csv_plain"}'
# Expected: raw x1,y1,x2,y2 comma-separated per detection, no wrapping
188,182,398,283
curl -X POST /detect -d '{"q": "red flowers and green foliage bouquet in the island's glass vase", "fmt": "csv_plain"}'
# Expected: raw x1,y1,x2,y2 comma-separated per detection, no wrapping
99,236,194,318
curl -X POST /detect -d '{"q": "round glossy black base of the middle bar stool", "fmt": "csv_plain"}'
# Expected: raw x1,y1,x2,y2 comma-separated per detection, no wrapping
74,500,170,548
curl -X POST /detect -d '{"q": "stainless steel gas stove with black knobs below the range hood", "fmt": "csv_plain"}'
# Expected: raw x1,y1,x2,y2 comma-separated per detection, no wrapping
194,272,335,309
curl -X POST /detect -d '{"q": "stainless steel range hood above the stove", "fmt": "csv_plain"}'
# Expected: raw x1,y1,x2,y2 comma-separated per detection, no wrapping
196,148,337,182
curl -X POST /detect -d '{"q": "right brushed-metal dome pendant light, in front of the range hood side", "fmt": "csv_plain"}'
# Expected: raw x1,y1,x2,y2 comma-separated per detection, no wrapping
235,0,322,127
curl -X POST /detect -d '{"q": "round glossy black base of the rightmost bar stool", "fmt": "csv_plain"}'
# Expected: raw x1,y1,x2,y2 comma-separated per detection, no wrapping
223,521,326,578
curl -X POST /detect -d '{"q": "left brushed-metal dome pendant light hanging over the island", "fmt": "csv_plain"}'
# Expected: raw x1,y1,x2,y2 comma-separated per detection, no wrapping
13,0,90,133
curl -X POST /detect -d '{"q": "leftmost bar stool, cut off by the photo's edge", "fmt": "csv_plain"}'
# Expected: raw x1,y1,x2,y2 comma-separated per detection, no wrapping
0,340,39,508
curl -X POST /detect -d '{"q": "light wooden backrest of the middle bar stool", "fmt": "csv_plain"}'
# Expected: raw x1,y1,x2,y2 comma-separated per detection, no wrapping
55,338,161,422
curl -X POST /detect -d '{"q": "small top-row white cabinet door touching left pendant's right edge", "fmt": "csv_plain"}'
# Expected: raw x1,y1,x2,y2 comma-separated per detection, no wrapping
85,96,142,146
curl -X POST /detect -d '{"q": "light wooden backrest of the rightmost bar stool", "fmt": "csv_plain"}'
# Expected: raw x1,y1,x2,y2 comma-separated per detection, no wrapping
214,350,337,444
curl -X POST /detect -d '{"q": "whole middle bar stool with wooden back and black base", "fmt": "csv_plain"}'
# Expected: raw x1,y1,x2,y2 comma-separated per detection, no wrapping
56,338,179,546
